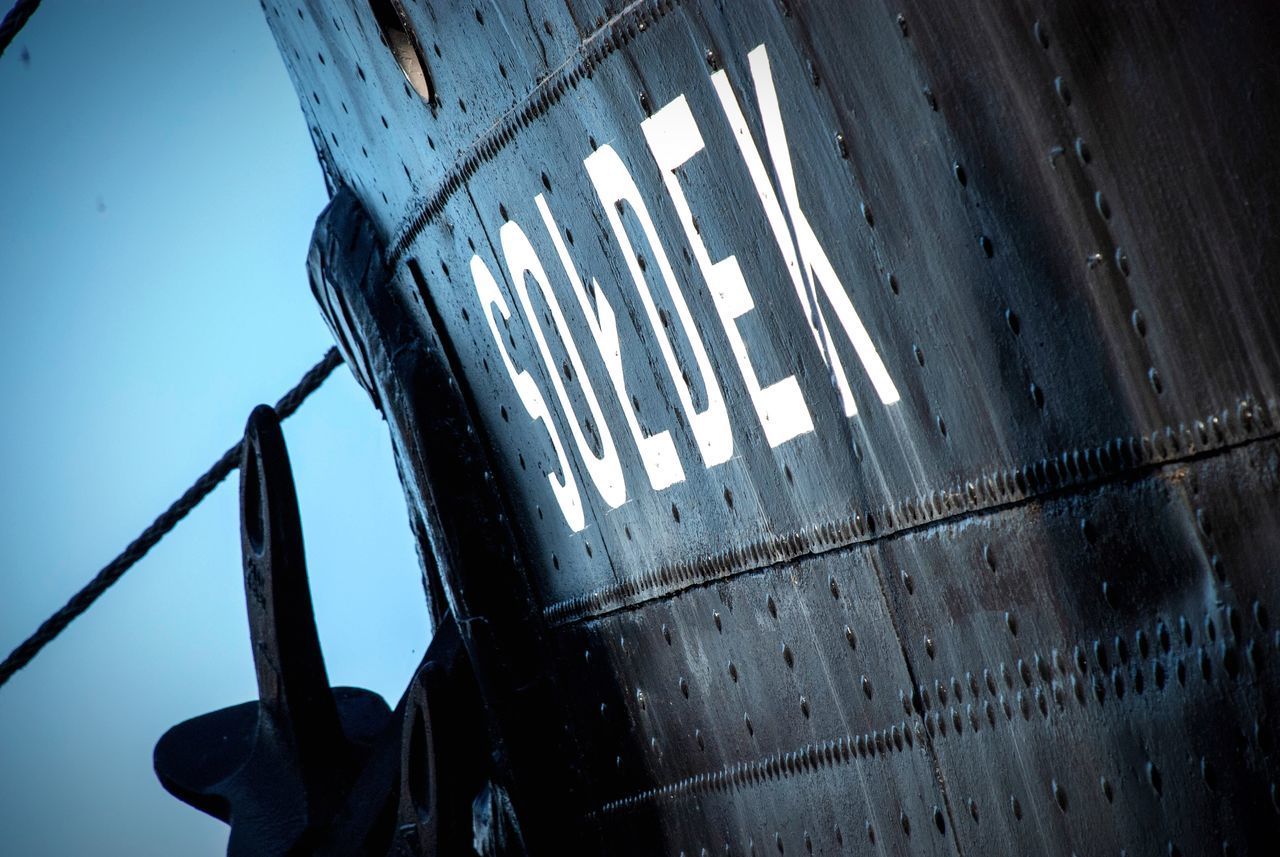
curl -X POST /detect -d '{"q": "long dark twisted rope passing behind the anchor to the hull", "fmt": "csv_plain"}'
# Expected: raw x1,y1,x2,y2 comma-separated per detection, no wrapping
0,347,342,687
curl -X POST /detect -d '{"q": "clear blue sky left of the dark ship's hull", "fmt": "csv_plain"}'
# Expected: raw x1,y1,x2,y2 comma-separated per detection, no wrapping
0,0,429,857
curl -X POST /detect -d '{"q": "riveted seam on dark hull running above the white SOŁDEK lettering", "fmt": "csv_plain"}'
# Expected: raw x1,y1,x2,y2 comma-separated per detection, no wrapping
387,0,681,269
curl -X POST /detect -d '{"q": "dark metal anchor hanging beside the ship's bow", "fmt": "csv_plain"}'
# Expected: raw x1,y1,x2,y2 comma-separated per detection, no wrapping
155,405,504,857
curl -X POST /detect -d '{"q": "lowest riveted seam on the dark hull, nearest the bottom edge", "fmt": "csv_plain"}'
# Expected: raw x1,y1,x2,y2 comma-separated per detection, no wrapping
588,611,1266,819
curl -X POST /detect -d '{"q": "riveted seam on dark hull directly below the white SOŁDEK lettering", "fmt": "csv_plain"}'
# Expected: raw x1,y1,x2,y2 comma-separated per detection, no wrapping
543,397,1280,627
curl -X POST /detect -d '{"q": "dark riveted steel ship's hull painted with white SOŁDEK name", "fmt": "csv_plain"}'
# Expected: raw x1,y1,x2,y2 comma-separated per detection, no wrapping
266,0,1280,853
